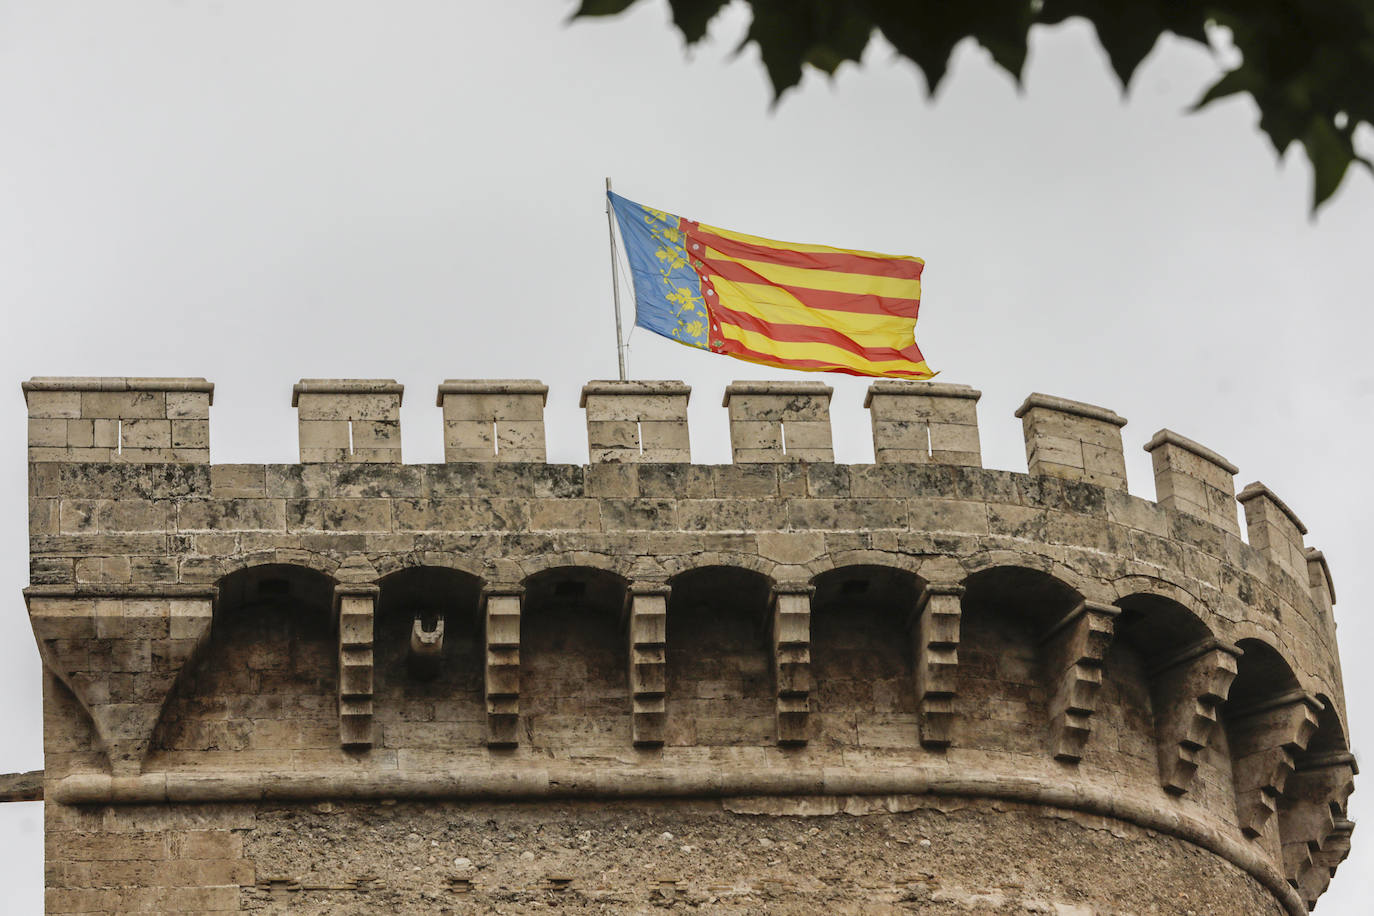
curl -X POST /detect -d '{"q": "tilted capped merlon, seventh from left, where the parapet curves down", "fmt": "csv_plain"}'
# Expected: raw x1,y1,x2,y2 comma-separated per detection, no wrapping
1017,394,1125,490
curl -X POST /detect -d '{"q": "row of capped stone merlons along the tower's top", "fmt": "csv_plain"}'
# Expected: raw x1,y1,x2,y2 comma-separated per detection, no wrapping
23,378,1341,590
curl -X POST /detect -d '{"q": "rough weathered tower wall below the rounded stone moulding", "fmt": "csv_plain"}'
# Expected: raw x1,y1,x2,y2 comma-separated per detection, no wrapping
49,797,1283,916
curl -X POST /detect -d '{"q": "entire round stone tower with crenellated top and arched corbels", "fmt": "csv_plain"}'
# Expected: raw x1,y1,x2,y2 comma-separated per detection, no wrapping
23,378,1355,916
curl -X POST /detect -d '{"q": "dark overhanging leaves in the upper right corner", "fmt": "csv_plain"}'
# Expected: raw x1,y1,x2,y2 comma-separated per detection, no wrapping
574,0,1374,211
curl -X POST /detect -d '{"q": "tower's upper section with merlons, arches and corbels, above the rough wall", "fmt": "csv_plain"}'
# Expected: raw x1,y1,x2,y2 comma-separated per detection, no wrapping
23,379,1355,915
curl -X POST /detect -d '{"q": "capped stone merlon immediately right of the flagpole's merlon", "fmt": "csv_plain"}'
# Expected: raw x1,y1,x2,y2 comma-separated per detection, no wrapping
721,382,835,463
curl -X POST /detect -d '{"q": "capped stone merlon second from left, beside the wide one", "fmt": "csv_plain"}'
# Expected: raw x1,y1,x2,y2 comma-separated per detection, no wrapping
291,379,405,464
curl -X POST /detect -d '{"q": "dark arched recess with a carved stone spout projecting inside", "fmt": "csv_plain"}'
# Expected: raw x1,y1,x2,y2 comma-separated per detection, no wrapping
374,564,486,753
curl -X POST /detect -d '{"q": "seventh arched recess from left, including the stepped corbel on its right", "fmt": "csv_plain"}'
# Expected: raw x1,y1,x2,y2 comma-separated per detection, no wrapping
1103,590,1238,809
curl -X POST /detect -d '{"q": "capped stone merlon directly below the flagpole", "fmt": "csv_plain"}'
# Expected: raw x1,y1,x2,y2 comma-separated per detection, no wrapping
580,382,691,463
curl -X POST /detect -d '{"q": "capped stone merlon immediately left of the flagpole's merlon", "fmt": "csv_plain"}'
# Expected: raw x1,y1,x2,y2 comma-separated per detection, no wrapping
434,379,548,461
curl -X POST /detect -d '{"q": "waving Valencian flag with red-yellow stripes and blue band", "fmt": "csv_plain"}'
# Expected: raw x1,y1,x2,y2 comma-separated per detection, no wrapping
607,191,934,379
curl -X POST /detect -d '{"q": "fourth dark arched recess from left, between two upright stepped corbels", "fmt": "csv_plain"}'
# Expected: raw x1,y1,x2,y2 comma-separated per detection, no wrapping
664,566,776,746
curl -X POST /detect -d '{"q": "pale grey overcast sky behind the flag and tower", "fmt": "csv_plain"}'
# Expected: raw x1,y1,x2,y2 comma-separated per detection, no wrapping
0,0,1374,916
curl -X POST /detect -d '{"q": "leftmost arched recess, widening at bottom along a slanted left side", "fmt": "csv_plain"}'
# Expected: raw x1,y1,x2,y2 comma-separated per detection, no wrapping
153,563,339,768
